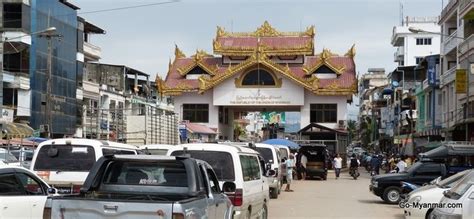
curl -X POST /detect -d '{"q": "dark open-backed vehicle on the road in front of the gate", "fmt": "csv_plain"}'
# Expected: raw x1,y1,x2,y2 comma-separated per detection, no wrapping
296,144,330,180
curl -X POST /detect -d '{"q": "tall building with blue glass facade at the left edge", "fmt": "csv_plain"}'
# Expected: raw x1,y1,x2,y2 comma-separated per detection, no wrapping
0,0,82,137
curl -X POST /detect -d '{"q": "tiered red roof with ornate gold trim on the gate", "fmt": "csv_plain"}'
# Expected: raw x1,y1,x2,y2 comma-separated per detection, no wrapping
157,22,357,95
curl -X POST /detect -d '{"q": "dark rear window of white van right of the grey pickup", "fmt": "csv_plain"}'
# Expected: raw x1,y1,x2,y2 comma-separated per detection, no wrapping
171,150,235,181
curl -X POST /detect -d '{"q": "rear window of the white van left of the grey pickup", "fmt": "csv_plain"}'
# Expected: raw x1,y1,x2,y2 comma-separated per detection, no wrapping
34,145,96,172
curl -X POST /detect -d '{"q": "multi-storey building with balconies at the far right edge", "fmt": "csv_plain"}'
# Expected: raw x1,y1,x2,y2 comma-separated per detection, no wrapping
439,0,474,141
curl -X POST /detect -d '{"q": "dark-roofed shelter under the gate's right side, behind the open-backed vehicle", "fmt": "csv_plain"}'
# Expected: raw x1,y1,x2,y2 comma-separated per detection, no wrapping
295,123,349,159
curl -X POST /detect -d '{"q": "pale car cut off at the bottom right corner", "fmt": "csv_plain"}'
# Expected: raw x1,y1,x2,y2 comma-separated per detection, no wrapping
430,170,474,219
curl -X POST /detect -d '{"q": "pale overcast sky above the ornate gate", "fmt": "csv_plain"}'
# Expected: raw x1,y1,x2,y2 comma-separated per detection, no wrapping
72,0,448,120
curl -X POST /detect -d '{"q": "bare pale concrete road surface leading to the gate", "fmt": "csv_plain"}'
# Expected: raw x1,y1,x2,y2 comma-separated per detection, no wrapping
268,168,404,219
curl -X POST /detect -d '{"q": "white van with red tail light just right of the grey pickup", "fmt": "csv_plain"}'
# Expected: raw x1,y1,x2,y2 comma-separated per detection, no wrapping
167,143,270,218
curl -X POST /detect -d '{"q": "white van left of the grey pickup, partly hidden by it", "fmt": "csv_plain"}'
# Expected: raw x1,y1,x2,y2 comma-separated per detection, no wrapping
30,138,138,194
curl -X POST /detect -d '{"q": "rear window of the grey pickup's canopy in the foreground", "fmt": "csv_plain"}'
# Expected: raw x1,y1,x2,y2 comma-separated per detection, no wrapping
104,160,188,187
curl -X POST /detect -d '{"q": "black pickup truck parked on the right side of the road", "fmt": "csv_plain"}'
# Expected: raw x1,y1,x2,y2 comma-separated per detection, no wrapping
369,161,448,204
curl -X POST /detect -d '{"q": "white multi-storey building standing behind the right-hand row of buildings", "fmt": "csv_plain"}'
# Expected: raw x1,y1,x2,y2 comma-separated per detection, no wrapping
391,17,440,66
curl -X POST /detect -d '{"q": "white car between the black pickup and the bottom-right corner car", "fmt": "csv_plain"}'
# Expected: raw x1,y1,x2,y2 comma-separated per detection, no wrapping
405,170,469,219
